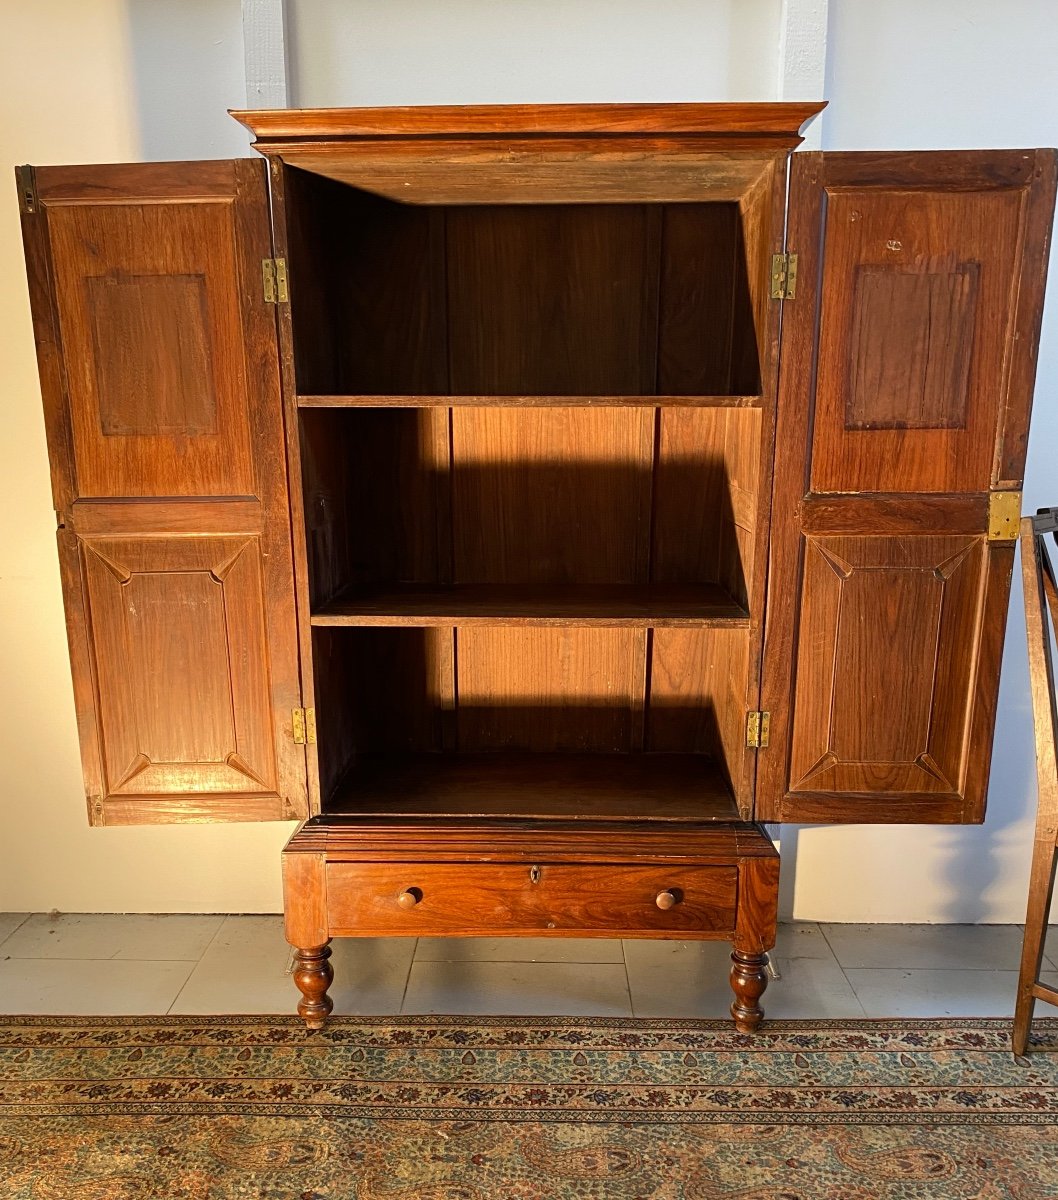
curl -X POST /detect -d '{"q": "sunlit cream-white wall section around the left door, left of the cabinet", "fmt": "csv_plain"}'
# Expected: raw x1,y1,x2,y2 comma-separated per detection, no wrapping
0,0,293,912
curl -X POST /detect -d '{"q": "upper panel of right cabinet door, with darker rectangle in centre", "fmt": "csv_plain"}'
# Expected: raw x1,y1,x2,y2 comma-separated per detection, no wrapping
811,186,1026,493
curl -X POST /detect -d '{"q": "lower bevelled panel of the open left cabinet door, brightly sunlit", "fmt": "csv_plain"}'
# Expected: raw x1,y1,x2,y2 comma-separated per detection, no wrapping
82,538,278,797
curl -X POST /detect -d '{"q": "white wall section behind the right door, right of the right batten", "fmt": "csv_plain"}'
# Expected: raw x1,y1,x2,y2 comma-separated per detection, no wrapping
782,0,1058,922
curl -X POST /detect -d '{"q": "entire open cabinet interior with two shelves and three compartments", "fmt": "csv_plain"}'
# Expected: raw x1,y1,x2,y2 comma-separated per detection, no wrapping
285,162,768,820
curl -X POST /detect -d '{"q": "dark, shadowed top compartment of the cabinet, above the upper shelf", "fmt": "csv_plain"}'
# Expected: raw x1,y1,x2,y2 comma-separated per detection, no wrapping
287,169,763,397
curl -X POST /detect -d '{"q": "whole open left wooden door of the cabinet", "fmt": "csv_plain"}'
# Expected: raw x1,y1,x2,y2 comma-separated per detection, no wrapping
19,160,306,824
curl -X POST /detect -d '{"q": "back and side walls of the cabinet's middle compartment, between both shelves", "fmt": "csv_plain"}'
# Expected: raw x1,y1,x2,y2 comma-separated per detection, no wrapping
300,407,761,608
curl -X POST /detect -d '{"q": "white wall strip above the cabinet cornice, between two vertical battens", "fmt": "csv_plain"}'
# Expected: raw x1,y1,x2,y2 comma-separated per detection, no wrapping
288,0,780,107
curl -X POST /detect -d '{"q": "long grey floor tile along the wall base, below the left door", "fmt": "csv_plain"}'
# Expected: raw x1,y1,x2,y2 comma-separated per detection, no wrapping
0,912,224,962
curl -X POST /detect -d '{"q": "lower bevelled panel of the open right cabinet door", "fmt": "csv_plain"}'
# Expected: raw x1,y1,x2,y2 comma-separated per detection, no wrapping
791,536,985,796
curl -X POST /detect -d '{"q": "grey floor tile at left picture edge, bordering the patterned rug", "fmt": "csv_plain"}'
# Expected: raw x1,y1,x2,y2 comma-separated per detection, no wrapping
0,959,192,1016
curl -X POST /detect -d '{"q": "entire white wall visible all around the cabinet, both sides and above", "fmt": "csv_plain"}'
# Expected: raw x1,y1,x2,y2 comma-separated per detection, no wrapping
0,0,1058,920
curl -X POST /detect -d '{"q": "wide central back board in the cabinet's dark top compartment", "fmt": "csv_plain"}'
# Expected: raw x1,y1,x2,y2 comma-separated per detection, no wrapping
446,205,660,395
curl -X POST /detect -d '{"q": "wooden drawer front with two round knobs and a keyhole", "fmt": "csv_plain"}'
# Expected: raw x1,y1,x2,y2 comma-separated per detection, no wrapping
326,863,738,937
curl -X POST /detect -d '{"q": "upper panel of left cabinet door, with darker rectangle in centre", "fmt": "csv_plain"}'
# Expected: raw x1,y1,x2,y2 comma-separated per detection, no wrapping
48,188,265,498
